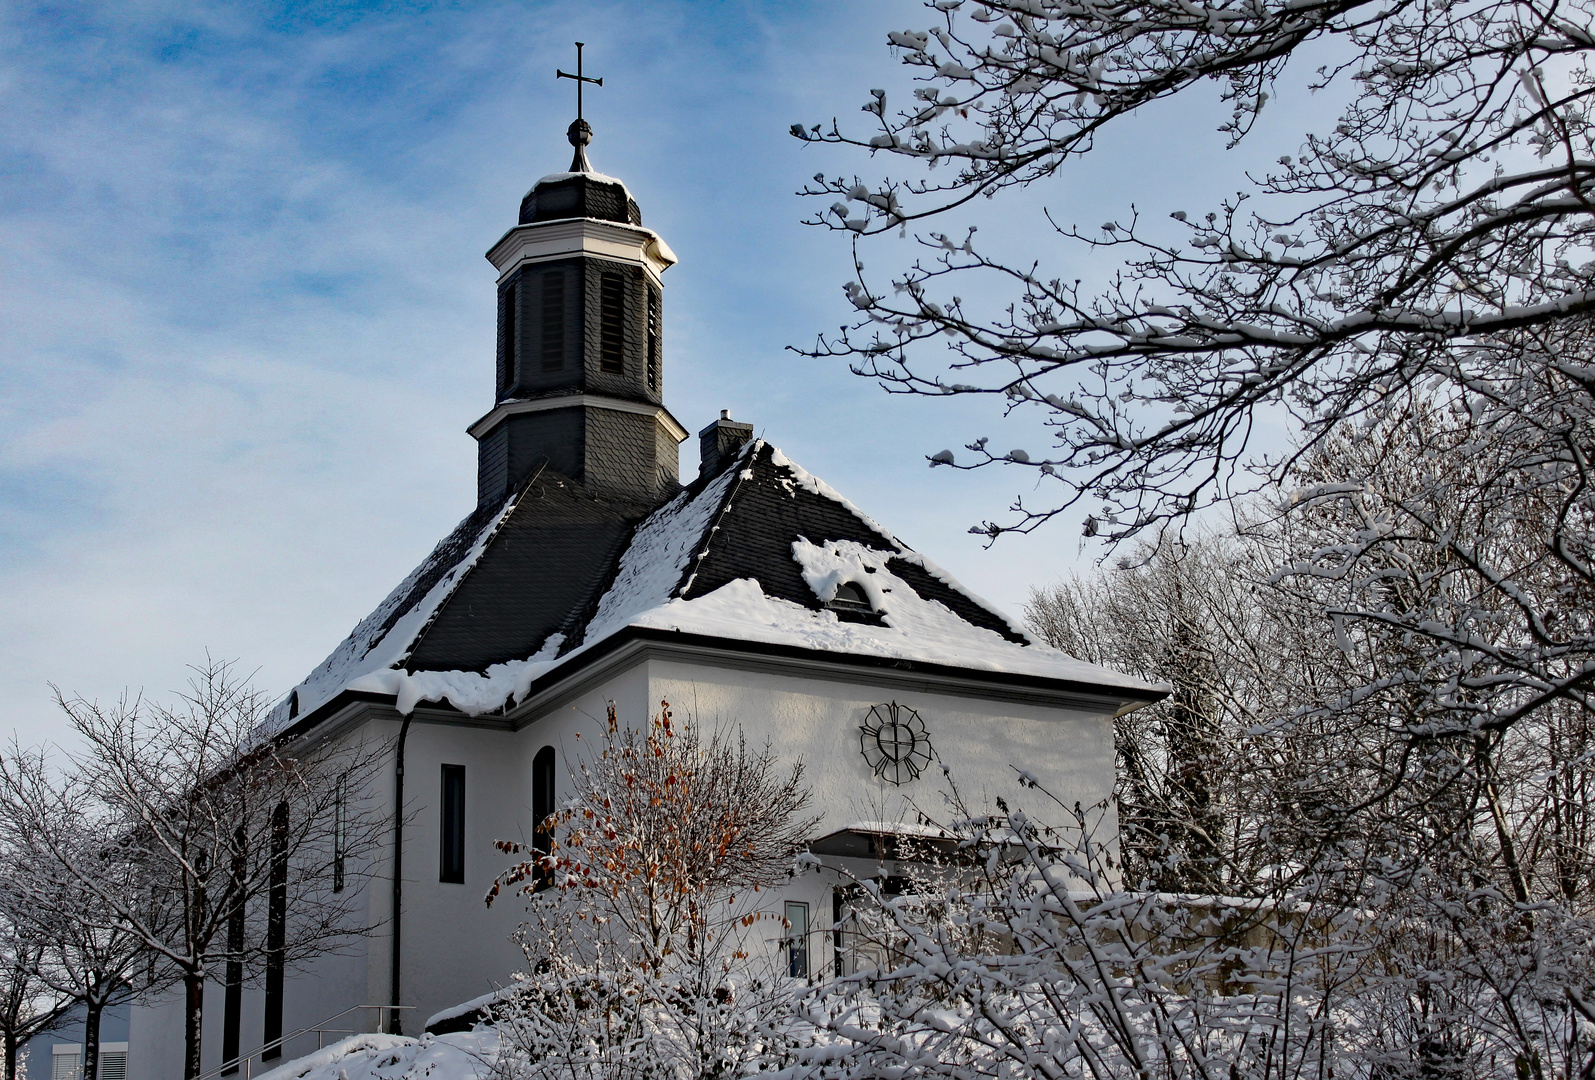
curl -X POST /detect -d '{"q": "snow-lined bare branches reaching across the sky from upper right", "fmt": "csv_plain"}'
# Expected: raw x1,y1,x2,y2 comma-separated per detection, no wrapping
798,0,1595,740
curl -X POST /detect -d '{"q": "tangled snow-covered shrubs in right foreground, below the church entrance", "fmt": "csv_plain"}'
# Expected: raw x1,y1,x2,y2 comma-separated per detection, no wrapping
785,772,1595,1080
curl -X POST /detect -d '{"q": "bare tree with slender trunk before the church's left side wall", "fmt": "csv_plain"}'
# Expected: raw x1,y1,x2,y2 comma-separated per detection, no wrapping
31,660,381,1077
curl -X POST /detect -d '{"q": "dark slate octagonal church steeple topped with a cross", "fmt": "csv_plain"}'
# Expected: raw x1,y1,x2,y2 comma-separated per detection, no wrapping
471,46,687,503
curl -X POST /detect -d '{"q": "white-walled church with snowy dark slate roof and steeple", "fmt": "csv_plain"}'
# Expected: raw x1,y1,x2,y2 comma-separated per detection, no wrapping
128,121,1161,1080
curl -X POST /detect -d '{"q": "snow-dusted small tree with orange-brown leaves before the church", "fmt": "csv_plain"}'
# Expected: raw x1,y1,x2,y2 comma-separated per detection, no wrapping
488,704,815,1080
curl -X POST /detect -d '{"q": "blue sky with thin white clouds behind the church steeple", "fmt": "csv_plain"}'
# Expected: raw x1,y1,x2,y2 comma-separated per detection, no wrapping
0,0,1333,742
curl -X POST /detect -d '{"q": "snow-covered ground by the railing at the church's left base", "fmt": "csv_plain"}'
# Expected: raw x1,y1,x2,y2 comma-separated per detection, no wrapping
258,1027,498,1080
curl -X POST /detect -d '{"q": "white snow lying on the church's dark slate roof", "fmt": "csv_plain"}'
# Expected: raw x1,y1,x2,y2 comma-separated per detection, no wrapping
279,440,1160,715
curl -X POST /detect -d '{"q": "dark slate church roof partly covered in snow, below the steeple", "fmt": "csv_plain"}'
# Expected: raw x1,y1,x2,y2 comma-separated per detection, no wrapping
273,442,1158,727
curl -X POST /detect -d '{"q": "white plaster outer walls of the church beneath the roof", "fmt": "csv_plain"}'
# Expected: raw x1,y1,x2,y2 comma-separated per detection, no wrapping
129,647,1113,1080
